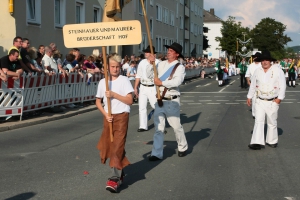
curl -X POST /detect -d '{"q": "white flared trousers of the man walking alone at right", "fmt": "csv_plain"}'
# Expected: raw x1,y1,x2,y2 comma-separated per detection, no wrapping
250,99,279,145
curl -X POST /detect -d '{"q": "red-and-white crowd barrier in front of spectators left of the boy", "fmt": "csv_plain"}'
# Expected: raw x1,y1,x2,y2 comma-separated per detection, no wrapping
0,73,101,121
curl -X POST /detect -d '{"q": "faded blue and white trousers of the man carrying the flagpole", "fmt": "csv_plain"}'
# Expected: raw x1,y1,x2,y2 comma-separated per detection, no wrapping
151,98,188,159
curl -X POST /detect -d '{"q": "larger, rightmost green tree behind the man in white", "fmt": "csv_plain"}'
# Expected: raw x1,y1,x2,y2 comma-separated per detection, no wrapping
250,17,292,59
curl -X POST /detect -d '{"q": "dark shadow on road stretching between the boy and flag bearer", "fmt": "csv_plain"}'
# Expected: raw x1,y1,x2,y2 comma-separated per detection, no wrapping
120,113,211,190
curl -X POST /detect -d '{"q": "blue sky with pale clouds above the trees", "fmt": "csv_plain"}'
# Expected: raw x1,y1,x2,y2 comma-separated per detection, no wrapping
204,0,300,46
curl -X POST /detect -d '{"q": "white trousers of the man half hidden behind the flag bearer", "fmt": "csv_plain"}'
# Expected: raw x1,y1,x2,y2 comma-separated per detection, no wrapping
139,84,156,130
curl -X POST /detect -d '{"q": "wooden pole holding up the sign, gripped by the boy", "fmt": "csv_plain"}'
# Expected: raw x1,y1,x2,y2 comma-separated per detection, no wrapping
102,47,114,142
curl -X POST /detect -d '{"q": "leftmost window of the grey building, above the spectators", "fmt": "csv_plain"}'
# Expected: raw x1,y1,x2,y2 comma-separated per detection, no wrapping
26,0,41,25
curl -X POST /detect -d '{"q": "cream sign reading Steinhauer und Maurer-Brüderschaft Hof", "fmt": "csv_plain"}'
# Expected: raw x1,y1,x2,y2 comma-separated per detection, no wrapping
63,20,142,48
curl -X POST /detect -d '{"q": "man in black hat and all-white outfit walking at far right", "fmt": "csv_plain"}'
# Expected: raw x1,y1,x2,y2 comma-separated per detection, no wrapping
247,51,286,150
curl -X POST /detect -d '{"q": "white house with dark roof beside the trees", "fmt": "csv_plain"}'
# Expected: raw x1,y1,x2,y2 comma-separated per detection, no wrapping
203,8,225,58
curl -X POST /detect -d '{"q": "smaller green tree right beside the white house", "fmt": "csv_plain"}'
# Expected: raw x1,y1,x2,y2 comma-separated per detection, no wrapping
215,16,251,55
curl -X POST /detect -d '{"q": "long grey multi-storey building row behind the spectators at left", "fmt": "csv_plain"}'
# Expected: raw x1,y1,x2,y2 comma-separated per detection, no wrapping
0,0,203,56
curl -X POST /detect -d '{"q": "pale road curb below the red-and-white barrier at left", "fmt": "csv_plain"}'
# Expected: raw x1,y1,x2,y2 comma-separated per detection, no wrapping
0,105,97,132
